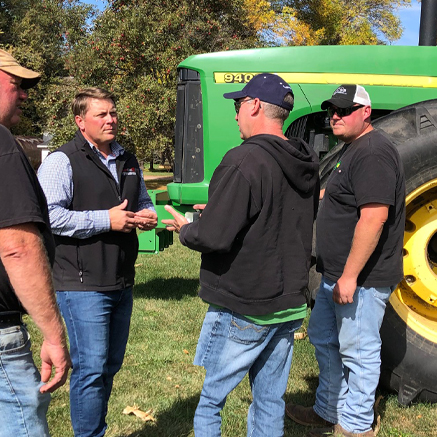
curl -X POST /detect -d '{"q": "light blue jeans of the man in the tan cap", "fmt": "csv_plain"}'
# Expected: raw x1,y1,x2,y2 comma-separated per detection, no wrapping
0,325,50,437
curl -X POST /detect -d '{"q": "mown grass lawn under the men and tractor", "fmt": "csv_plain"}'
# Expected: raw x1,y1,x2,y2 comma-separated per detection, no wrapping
25,238,437,437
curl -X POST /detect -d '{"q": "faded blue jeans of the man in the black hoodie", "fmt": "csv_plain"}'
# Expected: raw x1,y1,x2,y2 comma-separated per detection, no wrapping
194,306,302,437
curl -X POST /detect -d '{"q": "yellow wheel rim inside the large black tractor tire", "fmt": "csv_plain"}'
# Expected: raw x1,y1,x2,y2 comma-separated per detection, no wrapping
390,179,437,343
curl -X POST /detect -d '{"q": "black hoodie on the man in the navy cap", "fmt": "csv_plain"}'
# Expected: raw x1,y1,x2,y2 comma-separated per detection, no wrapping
180,134,319,316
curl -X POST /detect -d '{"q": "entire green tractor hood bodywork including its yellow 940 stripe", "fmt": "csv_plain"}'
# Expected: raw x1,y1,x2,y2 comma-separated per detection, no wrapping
168,46,437,205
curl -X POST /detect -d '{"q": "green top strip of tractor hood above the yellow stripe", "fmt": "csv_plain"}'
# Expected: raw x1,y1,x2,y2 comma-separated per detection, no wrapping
179,46,437,77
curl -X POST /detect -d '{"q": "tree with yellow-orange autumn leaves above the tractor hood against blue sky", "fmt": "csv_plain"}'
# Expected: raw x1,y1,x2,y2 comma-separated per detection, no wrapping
264,0,411,45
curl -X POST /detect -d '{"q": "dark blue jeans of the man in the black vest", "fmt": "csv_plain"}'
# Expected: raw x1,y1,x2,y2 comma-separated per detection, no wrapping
57,288,132,437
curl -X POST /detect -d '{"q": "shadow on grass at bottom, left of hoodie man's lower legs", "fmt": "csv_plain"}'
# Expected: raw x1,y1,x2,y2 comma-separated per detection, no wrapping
119,396,199,437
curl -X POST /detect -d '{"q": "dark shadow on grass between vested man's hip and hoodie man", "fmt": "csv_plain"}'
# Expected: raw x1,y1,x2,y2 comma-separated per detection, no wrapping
134,278,199,300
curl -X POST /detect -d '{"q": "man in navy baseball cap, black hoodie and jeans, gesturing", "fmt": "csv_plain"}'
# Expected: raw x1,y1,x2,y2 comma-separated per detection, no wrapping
163,73,319,437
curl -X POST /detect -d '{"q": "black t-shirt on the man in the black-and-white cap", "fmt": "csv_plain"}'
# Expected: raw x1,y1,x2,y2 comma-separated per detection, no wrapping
317,130,405,287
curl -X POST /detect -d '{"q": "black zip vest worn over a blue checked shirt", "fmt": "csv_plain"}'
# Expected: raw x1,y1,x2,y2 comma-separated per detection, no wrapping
53,131,141,291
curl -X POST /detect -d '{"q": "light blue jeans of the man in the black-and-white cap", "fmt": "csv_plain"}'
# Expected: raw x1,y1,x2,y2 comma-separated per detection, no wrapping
308,277,393,433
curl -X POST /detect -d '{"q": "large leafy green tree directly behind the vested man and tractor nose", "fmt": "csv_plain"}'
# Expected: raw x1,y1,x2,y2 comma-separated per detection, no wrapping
43,0,259,161
